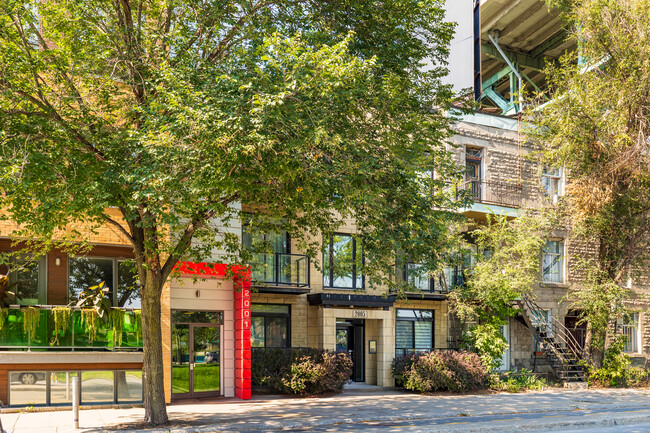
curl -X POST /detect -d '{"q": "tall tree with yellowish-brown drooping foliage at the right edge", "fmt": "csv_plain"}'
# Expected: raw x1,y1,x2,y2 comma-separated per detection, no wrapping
529,0,650,362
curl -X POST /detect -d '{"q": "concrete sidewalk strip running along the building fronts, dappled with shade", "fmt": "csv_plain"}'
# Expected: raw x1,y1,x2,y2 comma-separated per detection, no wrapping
6,389,650,433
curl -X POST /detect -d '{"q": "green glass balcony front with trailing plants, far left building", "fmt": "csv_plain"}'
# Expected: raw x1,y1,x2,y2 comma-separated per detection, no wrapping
0,305,142,351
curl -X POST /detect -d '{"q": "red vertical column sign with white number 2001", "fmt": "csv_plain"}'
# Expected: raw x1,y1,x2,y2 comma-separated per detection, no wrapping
234,270,251,400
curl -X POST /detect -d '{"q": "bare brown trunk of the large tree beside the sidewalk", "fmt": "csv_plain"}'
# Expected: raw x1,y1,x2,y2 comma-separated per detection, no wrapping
142,272,169,425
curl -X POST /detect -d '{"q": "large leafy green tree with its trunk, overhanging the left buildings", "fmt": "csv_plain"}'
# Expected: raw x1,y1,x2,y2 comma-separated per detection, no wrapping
0,0,461,424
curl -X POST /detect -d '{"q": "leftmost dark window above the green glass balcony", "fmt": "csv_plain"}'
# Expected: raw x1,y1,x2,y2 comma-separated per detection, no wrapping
9,256,47,305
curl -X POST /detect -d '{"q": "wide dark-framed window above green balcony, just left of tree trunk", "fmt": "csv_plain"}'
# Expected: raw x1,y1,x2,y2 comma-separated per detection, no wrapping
68,257,141,308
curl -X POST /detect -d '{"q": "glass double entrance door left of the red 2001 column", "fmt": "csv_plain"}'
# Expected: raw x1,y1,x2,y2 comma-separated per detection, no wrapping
172,311,221,399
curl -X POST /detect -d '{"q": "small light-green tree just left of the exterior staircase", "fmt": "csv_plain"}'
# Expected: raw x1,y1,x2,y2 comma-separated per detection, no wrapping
449,209,557,369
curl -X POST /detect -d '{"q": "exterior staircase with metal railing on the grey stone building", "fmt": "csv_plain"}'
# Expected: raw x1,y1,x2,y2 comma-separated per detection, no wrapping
518,296,586,385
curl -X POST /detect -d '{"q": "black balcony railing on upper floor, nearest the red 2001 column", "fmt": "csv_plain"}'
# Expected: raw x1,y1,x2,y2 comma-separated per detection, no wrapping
251,253,309,287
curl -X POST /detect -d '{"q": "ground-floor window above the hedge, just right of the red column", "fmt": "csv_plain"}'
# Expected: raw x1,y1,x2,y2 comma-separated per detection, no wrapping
251,304,291,347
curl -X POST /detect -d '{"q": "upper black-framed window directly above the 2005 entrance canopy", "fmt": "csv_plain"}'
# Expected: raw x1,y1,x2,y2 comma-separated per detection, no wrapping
323,234,364,289
